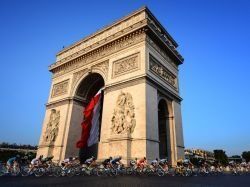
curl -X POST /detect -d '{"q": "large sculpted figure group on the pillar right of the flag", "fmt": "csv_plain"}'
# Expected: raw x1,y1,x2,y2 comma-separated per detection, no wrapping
111,92,136,134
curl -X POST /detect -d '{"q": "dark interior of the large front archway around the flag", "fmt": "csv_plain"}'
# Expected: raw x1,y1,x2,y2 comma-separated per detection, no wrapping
75,73,105,161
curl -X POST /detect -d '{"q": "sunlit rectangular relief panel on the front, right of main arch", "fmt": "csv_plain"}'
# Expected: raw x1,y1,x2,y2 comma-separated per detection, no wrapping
113,53,139,77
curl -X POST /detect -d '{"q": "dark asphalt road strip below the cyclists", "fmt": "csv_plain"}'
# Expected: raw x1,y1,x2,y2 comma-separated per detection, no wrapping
0,175,250,187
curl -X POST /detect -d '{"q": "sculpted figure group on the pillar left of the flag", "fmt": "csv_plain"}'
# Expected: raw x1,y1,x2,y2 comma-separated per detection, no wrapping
44,109,60,144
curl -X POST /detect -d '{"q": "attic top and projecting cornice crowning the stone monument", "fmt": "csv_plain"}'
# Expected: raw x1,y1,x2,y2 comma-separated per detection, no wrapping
49,7,183,71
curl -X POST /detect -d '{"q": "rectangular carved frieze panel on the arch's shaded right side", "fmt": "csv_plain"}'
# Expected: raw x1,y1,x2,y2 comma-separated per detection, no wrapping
149,55,177,89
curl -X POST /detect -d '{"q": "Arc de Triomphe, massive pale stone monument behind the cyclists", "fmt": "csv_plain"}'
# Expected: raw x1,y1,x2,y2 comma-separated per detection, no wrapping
37,7,184,164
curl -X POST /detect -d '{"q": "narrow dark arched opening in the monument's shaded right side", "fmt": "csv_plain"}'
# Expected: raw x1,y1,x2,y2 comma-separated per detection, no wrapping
158,99,169,159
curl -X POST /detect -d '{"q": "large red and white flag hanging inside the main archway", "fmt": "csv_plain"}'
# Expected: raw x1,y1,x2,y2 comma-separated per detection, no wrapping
76,88,103,148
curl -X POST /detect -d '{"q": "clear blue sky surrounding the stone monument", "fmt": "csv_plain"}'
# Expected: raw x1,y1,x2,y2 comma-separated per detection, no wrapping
0,0,250,155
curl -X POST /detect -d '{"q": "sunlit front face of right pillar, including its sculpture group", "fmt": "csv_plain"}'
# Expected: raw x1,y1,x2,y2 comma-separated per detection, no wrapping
98,82,147,164
